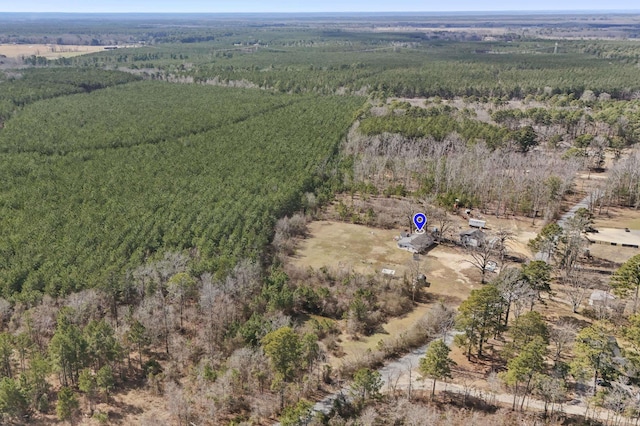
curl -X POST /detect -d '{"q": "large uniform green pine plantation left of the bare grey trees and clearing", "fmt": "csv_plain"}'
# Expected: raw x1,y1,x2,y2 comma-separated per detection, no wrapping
0,83,362,298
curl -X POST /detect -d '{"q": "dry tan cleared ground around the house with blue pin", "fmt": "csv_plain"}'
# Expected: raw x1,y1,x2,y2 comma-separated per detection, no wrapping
291,216,539,366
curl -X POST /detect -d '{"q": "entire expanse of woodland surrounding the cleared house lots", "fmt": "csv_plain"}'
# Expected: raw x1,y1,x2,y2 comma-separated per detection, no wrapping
0,13,640,426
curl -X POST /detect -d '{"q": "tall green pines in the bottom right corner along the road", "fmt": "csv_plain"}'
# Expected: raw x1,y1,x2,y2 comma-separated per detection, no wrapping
450,260,640,416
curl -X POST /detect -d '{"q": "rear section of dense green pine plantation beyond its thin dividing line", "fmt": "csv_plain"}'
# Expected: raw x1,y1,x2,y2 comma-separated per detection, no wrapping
0,82,296,155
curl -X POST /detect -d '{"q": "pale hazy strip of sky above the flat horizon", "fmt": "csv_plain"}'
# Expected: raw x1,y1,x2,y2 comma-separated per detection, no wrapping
0,0,640,13
